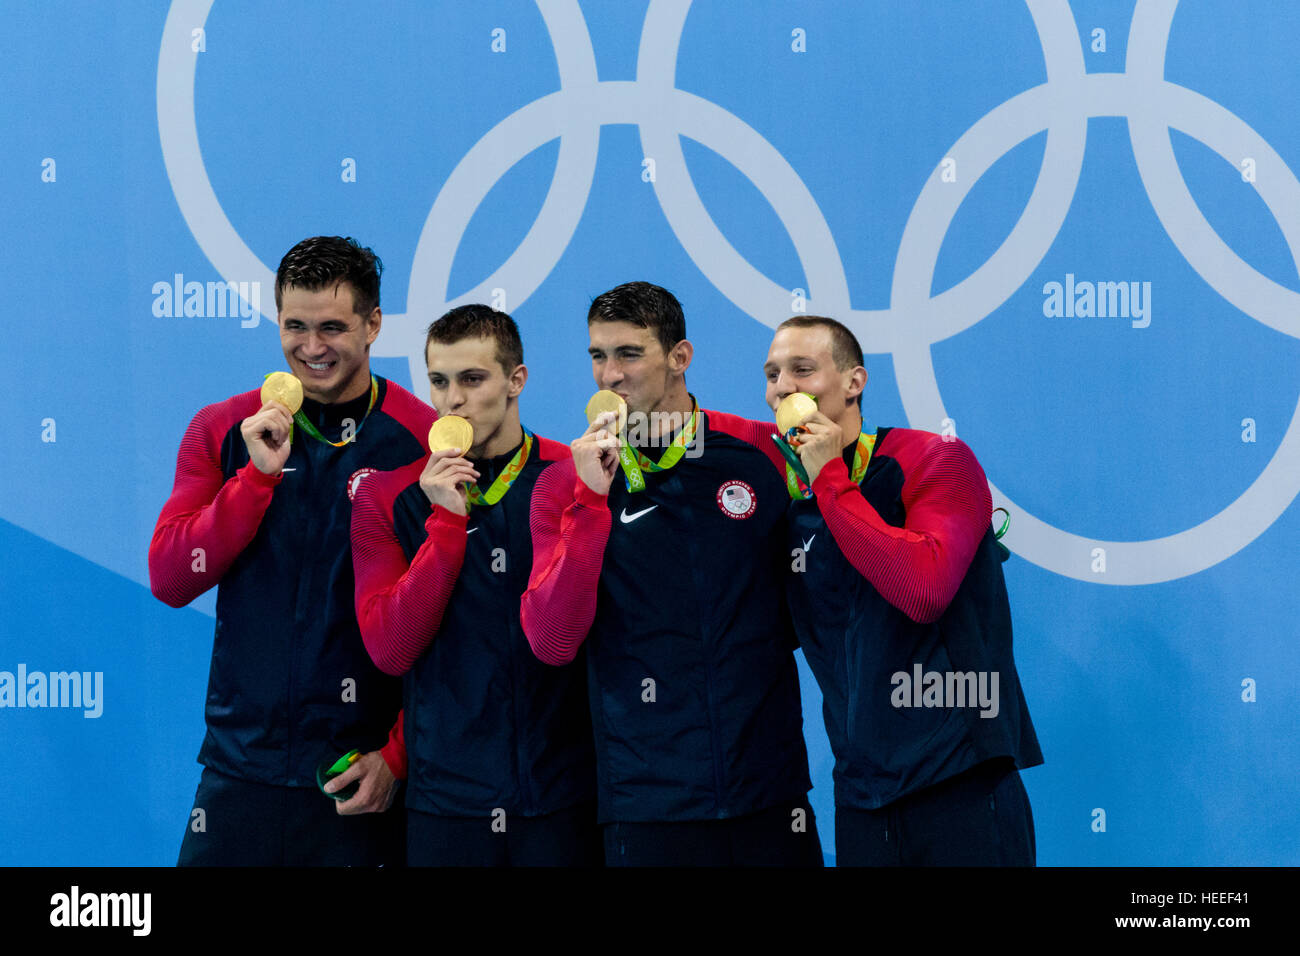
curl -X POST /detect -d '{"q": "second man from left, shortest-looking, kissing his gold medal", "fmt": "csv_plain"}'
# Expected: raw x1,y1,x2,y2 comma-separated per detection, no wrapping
352,304,601,866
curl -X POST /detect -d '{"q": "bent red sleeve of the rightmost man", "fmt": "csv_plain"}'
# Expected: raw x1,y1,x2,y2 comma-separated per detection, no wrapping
813,429,993,624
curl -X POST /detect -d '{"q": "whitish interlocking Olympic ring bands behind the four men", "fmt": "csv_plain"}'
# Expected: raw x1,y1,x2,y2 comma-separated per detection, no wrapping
157,0,1300,584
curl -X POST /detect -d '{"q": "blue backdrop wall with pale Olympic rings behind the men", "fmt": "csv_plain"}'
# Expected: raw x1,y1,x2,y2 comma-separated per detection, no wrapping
0,0,1300,865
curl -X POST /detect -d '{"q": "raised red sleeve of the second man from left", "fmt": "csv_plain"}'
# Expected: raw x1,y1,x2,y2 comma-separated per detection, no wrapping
352,462,469,675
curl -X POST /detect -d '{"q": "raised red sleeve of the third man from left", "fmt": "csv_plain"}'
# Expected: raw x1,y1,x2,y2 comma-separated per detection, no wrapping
519,459,619,666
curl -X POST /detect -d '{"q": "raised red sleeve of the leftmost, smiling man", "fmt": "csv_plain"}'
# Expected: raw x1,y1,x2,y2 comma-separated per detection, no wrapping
150,397,281,607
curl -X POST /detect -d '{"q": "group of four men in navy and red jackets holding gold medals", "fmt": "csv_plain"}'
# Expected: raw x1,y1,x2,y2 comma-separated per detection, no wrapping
151,247,1041,866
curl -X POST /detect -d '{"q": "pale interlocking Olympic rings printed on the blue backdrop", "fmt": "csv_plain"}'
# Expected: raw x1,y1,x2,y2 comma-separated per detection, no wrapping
157,0,1300,585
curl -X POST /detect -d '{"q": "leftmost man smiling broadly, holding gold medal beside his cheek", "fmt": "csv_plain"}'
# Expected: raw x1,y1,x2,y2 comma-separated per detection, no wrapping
150,237,434,866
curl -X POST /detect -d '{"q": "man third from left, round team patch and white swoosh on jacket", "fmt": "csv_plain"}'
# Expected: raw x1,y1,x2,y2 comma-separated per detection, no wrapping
521,282,822,866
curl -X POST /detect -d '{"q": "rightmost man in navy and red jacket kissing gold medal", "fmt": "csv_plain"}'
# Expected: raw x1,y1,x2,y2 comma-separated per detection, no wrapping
763,316,1043,866
